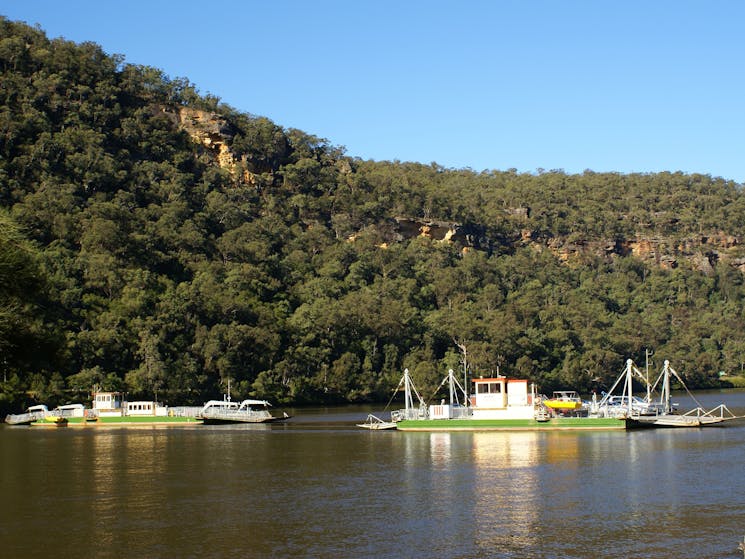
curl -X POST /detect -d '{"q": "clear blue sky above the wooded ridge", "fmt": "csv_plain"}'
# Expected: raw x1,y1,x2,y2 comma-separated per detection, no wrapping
0,0,745,183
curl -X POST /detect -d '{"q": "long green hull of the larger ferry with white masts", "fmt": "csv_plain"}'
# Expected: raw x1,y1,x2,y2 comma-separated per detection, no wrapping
396,417,626,431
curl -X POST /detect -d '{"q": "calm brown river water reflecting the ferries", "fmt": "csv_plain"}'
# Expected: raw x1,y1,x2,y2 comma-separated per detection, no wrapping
0,392,745,559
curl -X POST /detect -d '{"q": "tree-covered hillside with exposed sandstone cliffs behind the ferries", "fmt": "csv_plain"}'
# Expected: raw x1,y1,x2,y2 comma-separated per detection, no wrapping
0,19,745,411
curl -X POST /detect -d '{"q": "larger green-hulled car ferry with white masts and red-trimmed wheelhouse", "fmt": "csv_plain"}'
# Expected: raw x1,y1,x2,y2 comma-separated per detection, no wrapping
391,359,745,431
